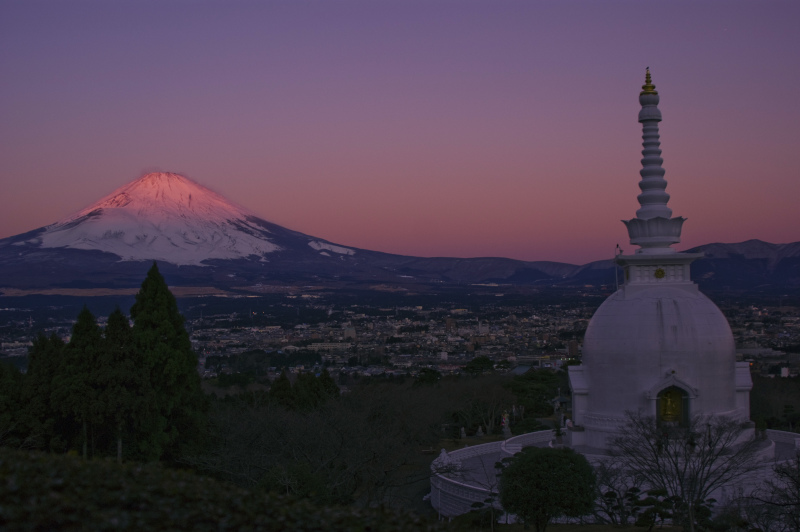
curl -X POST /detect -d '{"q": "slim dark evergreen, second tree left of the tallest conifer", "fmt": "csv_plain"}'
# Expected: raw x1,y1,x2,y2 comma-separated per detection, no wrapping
50,306,102,458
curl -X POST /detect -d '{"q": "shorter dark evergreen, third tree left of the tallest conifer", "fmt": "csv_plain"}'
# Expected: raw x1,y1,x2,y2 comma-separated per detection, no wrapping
22,333,69,451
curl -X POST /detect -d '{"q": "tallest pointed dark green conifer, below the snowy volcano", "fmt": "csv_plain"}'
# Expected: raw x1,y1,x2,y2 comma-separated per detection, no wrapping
131,263,205,460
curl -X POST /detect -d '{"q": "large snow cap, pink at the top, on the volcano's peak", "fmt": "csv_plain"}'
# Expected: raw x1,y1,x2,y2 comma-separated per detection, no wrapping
27,173,280,265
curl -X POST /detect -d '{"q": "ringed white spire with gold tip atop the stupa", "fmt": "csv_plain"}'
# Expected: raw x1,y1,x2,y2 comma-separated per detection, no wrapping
623,67,685,253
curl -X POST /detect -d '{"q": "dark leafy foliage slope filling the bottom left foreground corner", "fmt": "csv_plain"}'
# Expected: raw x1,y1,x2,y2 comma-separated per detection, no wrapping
0,448,440,532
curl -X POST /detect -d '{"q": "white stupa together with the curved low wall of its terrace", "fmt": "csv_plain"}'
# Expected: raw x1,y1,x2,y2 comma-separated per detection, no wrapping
427,69,800,517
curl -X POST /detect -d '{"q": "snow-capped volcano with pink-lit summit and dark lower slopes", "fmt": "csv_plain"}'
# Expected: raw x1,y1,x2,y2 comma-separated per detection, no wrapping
0,172,394,288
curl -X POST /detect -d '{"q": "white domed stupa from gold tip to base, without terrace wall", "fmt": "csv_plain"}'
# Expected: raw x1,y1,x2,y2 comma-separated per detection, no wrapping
569,69,752,449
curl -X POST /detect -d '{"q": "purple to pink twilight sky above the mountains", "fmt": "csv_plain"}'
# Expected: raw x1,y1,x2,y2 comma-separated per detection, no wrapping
0,0,800,263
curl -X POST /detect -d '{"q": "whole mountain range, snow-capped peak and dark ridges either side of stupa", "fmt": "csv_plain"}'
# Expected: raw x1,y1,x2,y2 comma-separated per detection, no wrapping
0,173,800,293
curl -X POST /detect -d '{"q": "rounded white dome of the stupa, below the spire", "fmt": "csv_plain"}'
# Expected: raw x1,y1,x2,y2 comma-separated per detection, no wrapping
583,285,736,417
